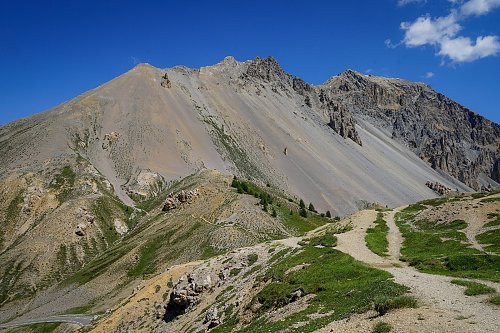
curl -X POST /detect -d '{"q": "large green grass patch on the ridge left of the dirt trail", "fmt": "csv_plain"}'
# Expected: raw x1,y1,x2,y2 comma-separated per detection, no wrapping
230,245,408,332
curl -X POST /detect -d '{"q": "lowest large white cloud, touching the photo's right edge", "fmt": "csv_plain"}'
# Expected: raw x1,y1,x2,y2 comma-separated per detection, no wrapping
438,36,500,62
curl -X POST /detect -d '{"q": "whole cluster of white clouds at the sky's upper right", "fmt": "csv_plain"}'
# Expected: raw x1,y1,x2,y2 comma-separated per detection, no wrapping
396,0,500,63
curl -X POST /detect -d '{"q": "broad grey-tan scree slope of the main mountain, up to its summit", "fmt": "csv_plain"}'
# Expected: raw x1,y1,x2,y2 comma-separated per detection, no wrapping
0,58,478,214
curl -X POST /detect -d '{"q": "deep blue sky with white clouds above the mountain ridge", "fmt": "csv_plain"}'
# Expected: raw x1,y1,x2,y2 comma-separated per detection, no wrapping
0,0,500,124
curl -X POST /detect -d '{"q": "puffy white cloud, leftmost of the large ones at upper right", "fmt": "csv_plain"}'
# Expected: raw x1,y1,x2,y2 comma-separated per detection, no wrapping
401,13,461,47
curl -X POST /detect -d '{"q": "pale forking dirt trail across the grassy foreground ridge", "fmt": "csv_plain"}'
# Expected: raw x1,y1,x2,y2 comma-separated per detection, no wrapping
326,207,500,333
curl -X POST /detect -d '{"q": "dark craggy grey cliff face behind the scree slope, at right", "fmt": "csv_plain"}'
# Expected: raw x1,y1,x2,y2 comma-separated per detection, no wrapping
325,70,500,190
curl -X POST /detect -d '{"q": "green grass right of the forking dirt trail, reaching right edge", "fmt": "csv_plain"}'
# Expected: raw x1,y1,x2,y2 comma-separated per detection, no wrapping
396,210,500,282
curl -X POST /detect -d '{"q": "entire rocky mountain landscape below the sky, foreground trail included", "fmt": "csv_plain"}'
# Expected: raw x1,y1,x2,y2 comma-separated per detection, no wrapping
0,57,500,332
